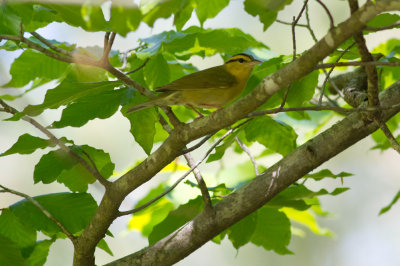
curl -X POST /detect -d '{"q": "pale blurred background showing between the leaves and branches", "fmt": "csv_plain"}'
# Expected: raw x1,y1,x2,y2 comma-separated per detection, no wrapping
0,0,400,266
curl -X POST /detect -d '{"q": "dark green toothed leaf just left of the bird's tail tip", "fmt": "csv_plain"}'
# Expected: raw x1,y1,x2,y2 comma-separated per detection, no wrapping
52,87,135,128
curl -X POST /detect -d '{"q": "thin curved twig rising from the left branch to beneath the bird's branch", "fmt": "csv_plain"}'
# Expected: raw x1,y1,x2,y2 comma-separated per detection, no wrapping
117,118,251,216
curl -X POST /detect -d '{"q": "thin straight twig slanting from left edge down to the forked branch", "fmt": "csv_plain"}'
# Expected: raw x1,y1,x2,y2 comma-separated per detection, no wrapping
0,99,110,187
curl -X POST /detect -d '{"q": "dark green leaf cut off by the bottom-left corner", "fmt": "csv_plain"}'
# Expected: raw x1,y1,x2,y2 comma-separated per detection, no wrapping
0,235,26,266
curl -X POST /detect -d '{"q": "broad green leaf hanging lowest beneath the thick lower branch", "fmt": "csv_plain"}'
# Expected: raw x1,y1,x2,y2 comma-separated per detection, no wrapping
251,207,292,254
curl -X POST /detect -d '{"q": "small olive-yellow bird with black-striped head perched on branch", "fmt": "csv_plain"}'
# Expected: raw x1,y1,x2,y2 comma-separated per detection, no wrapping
127,53,261,116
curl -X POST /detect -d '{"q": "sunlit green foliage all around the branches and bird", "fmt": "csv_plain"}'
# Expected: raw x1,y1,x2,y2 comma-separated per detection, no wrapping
0,0,400,265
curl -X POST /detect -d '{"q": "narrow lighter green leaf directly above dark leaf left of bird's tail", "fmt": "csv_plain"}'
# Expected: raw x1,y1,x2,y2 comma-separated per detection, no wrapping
23,80,121,116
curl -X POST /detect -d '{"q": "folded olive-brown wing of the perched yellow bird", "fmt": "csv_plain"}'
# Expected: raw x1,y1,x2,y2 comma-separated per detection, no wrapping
156,66,237,92
